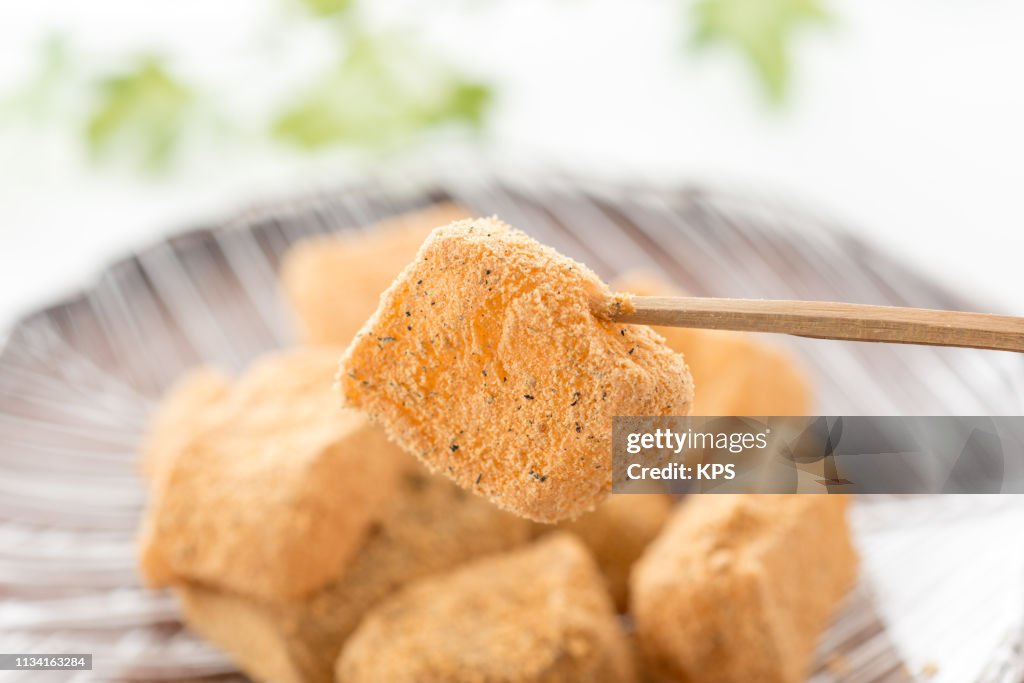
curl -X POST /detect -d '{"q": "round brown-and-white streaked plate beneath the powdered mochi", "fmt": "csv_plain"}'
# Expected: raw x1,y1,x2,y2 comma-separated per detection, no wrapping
0,167,1024,683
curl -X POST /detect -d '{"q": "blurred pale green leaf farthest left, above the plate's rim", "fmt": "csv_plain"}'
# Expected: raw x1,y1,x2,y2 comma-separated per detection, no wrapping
86,56,194,170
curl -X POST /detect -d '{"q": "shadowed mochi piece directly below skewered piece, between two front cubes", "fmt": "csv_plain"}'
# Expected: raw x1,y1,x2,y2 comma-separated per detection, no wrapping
558,494,673,611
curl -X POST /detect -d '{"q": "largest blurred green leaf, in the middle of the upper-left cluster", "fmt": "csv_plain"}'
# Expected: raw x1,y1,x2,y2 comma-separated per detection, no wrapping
272,34,492,150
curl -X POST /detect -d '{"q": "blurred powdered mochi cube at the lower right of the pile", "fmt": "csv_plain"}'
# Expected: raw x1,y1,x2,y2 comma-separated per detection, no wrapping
630,495,857,683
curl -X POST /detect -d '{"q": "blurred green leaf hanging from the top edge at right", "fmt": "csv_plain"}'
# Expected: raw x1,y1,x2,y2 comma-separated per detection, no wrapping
694,0,828,102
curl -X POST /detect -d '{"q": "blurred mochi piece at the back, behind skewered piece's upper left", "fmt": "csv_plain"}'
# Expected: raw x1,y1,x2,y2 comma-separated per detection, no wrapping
281,204,469,347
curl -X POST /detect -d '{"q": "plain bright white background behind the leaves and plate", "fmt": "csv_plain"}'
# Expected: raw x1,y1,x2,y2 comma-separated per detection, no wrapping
0,0,1024,329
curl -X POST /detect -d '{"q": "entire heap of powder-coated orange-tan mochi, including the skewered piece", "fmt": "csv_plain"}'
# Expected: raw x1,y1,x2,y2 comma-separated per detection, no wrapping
139,205,857,683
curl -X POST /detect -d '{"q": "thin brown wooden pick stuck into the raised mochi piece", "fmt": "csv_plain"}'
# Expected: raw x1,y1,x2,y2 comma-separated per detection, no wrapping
610,296,1024,352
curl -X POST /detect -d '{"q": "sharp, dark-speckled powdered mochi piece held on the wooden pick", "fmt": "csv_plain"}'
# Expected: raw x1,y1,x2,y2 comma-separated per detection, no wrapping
339,218,693,522
